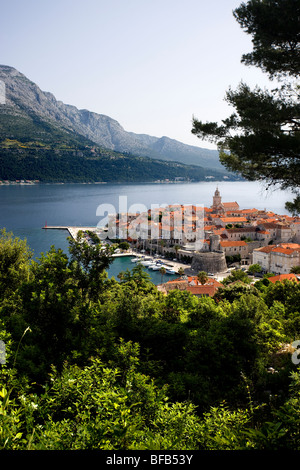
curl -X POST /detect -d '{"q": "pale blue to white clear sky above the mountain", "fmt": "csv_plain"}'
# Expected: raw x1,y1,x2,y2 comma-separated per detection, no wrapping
0,0,269,148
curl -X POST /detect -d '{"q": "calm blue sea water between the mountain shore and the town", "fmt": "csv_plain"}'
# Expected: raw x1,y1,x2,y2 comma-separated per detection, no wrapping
0,182,291,283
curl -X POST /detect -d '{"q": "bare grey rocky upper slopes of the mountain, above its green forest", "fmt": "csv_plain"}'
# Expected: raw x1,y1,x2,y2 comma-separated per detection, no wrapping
0,65,227,174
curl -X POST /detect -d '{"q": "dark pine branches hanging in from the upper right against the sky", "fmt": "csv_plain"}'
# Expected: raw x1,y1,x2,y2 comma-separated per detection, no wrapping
192,0,300,213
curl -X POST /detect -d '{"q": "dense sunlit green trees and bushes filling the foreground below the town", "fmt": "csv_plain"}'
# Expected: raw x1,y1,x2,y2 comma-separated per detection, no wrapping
0,231,300,450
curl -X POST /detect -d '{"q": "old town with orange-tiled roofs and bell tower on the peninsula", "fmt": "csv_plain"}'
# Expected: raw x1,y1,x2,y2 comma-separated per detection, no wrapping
48,187,300,296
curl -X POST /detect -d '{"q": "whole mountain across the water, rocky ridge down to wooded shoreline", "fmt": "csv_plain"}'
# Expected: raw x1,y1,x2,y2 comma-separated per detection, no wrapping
0,65,232,182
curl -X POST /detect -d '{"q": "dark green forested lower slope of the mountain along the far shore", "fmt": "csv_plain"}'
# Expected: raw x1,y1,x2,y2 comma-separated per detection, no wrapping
0,145,227,183
